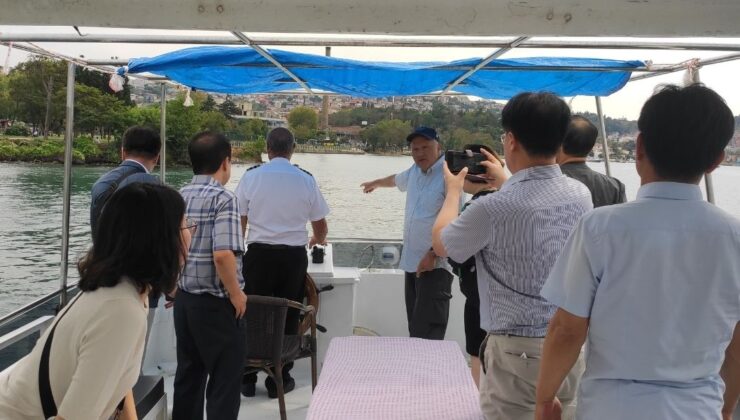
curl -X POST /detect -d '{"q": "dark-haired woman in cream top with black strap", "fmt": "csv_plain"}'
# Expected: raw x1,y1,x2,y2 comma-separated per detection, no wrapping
0,183,195,420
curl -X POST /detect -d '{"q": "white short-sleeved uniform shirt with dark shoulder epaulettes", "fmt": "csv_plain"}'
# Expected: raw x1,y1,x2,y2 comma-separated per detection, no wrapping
236,157,329,246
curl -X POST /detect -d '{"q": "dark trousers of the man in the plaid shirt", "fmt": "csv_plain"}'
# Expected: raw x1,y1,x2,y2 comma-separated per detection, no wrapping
172,290,247,420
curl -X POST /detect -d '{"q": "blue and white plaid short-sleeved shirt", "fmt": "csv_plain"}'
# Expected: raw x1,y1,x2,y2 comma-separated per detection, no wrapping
178,175,244,298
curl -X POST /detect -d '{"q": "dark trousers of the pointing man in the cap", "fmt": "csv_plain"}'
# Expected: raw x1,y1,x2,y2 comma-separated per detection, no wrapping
405,268,452,340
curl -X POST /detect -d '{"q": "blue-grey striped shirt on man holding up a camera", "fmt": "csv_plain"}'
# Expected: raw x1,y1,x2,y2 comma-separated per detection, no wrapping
442,165,593,337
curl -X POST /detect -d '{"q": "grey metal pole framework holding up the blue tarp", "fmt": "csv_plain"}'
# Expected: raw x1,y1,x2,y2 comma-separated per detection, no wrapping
0,31,740,316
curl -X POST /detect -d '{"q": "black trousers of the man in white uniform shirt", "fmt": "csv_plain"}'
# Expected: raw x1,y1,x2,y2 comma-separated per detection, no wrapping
242,243,308,383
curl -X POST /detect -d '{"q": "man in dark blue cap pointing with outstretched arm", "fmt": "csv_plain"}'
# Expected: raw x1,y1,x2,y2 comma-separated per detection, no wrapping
361,127,452,340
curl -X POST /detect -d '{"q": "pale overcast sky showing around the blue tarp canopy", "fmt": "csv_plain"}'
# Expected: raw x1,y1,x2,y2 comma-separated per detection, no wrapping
0,26,740,119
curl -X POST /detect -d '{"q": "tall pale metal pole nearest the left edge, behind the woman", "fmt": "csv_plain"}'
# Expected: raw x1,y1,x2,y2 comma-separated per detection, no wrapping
59,63,75,308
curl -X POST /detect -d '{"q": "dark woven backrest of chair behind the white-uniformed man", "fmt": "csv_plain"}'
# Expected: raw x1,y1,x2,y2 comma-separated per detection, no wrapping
245,295,288,362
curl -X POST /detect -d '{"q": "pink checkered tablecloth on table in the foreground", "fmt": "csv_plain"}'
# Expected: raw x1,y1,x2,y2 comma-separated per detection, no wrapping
307,337,483,420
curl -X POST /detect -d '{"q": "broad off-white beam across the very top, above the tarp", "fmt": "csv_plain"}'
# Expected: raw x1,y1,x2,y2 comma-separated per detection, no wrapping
0,0,740,37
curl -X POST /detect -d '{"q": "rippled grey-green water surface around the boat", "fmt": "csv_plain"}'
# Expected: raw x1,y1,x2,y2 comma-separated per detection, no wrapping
0,154,740,315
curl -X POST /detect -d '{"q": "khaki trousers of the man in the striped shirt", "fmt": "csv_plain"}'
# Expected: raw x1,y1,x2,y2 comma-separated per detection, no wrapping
480,335,584,420
